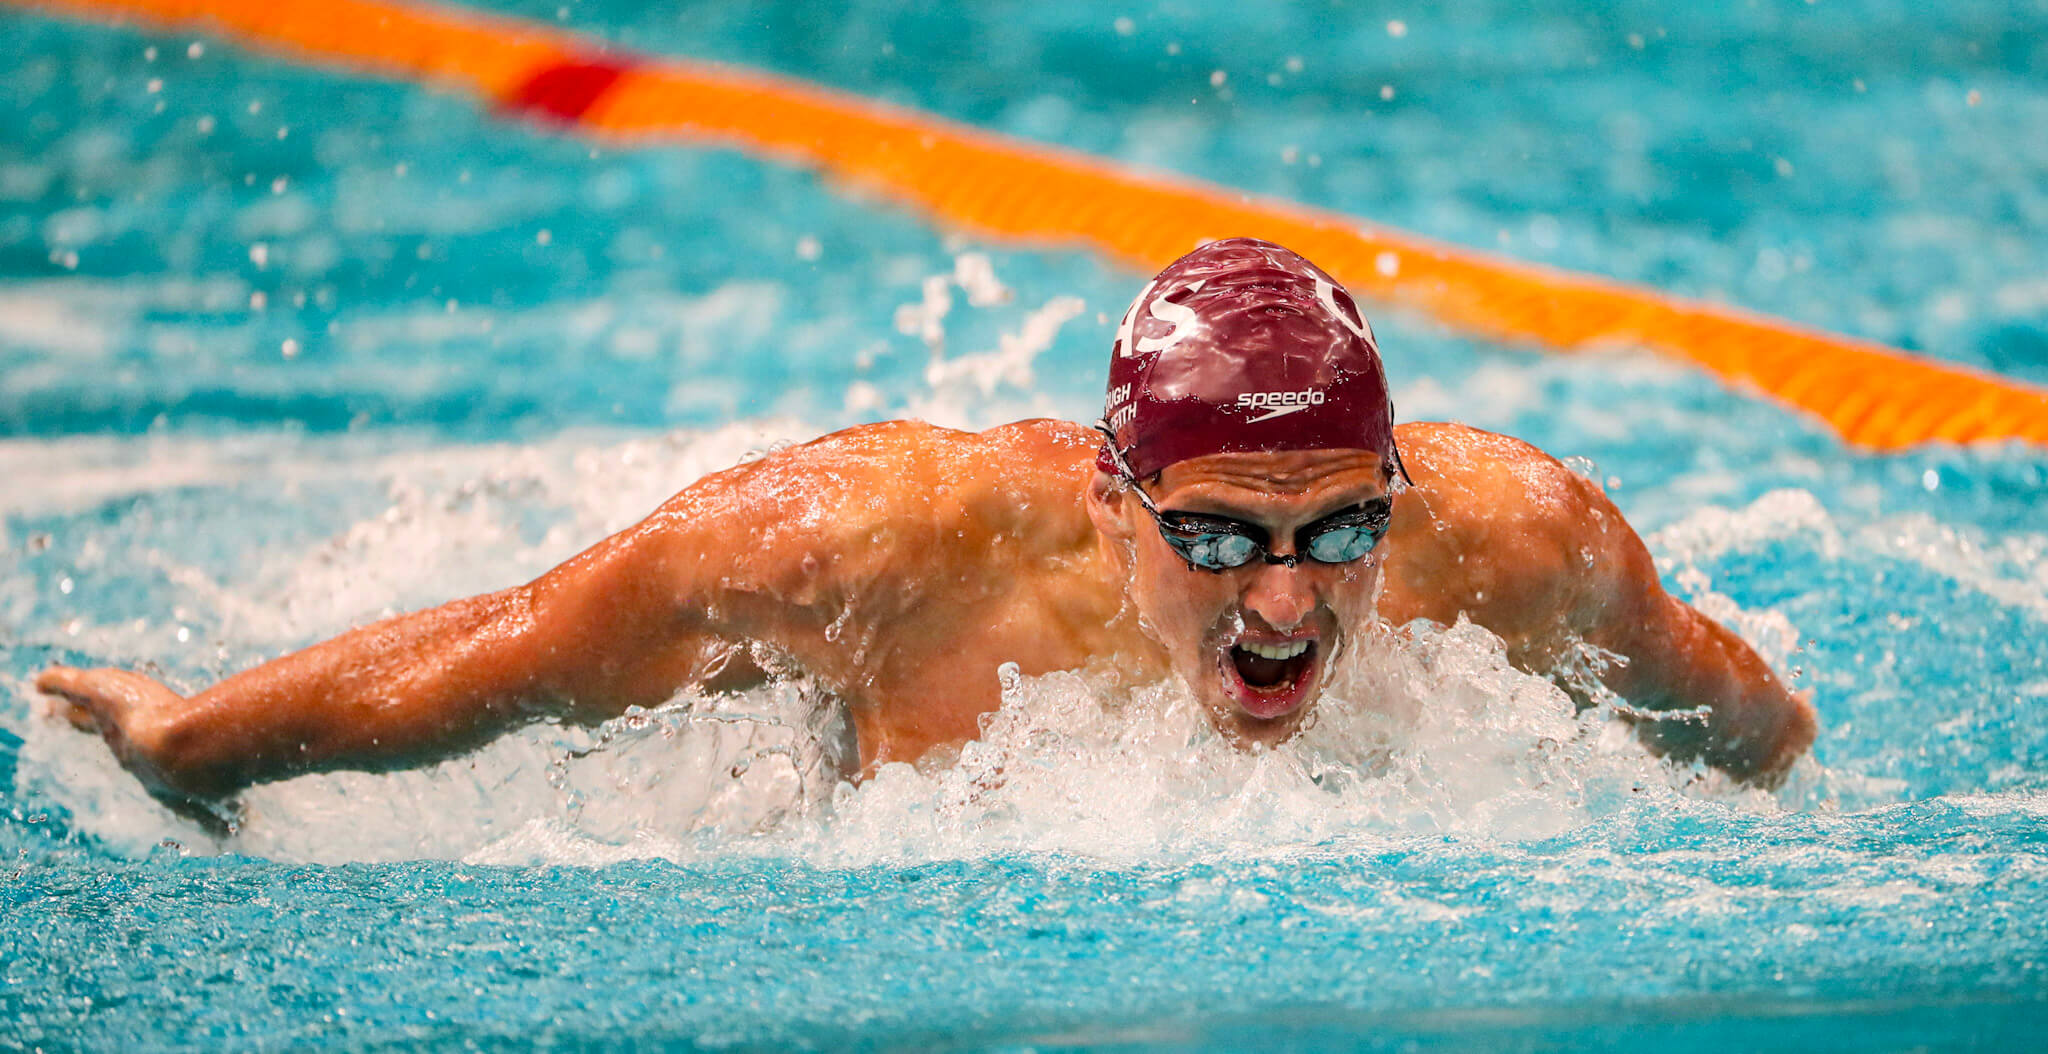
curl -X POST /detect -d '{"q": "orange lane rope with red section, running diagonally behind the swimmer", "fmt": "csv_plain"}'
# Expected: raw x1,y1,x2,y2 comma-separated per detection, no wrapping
16,0,2048,450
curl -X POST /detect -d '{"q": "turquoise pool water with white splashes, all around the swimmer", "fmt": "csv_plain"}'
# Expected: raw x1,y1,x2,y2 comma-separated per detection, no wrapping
0,0,2048,1050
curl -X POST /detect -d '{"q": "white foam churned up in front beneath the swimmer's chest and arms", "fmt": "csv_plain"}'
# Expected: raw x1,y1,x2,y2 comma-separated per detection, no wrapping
16,609,1810,866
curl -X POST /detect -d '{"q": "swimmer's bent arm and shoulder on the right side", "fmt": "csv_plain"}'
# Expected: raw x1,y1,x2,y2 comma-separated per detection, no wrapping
1382,424,1815,786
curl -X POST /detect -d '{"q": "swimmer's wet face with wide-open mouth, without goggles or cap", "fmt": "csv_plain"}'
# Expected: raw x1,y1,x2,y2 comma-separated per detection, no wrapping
1092,450,1389,743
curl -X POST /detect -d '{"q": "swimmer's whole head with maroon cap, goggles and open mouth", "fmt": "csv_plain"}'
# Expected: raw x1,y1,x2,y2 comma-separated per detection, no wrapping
1087,237,1405,743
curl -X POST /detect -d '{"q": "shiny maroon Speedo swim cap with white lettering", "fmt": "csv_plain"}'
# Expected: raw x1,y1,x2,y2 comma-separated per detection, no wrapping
1096,237,1401,479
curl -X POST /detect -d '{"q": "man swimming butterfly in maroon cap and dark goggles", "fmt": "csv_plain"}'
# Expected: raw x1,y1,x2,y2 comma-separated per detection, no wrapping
37,237,1815,818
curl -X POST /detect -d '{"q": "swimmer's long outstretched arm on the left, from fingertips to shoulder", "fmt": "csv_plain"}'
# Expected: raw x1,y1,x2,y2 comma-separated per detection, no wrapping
37,426,930,800
